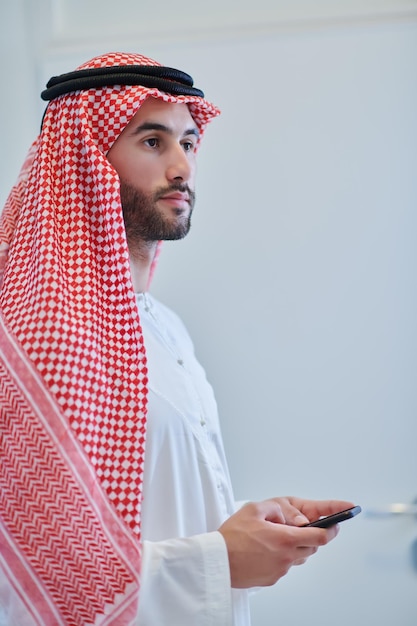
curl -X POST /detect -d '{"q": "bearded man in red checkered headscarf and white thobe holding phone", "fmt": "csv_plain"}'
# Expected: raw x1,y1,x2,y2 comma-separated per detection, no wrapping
0,53,350,626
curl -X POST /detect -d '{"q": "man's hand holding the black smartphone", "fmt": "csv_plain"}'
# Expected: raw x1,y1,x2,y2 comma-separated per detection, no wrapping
219,498,353,588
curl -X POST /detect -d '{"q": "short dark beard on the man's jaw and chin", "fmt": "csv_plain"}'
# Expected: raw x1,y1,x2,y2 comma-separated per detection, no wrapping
120,181,195,247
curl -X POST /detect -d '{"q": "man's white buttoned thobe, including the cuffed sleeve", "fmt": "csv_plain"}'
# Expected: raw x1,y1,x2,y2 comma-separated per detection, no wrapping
137,294,250,626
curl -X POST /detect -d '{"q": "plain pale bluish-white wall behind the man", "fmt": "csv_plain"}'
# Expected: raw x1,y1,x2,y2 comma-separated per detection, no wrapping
0,0,417,626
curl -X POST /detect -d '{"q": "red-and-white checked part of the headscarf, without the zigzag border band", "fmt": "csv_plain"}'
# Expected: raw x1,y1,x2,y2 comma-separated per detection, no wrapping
0,53,218,620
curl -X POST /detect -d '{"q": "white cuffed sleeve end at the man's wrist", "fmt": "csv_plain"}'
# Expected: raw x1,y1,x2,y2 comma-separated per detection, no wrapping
135,531,233,626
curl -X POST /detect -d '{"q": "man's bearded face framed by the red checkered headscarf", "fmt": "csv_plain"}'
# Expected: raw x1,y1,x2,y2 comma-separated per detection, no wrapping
107,98,198,246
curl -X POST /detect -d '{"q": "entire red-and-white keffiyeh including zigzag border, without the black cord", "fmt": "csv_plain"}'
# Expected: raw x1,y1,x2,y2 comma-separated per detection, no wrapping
0,53,218,626
